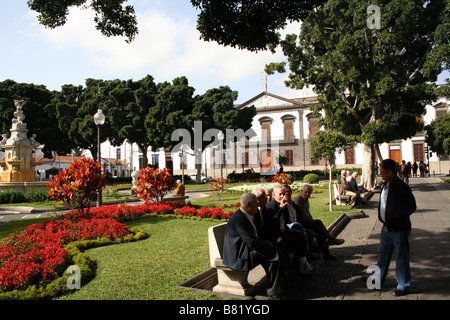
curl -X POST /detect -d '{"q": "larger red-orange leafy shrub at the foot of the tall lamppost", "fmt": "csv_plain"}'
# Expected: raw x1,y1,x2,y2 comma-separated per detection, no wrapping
47,158,106,216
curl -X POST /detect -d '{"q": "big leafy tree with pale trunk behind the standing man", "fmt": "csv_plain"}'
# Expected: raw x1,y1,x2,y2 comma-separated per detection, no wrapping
266,0,449,188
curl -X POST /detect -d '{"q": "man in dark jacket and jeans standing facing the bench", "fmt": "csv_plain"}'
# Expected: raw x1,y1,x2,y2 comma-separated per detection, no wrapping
377,159,417,297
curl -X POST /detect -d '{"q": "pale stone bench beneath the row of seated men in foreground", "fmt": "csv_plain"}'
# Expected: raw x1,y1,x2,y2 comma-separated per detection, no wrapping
208,222,265,296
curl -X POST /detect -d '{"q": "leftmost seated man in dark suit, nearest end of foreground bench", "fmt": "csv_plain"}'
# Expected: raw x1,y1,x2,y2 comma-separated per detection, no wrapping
223,193,288,299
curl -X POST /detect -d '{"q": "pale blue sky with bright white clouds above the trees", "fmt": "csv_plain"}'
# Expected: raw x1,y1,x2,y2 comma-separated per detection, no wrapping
0,0,448,103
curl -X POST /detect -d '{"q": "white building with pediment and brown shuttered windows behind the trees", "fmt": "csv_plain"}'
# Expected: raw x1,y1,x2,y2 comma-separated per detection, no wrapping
31,92,450,177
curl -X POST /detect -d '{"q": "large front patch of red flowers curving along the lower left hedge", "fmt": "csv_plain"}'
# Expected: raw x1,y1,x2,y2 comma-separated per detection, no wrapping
0,216,128,291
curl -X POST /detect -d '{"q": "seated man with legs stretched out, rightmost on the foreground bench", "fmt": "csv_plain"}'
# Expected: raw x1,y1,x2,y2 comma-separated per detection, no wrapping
293,184,344,259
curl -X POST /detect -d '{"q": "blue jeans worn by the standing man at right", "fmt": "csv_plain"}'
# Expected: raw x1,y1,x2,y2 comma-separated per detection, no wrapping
377,226,411,290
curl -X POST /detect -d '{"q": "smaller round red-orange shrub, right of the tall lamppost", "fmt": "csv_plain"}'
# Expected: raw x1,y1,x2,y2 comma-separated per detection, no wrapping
136,167,175,202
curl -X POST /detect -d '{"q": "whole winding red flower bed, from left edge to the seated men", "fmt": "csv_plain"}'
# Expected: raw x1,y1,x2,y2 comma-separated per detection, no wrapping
0,202,233,292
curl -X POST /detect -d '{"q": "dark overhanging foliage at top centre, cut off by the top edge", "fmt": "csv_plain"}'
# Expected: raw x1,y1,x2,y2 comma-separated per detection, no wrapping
191,0,326,51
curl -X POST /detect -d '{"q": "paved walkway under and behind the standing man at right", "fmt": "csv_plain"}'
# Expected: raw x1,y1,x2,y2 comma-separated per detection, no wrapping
285,177,450,300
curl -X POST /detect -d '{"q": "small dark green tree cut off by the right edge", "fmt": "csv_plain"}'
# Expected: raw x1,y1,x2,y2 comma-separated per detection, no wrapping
425,114,450,156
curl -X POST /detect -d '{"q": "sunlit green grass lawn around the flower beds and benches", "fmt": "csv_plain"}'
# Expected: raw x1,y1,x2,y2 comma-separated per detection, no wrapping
0,185,356,300
